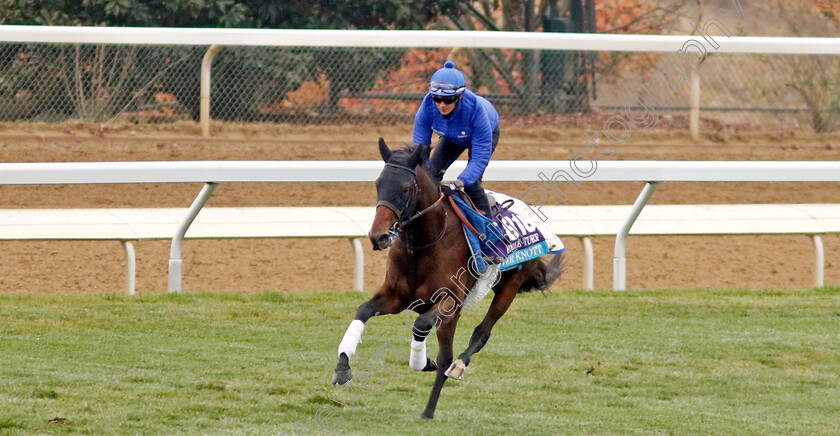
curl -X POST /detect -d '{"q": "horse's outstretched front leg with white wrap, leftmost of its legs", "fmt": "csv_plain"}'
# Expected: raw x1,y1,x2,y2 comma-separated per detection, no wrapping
332,287,404,385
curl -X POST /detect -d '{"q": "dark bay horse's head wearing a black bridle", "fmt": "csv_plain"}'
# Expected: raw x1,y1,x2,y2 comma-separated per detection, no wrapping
368,138,429,250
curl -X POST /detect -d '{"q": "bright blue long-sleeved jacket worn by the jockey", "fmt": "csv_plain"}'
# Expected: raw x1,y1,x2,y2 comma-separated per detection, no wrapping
412,90,499,186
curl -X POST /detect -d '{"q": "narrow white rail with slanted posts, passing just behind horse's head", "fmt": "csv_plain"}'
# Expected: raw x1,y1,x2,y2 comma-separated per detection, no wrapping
0,161,840,292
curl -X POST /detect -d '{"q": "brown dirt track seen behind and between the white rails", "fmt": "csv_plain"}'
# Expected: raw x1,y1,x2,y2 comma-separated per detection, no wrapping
0,118,840,294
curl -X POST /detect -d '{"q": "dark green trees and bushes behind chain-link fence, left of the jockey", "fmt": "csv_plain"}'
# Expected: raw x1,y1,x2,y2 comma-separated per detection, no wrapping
0,0,457,119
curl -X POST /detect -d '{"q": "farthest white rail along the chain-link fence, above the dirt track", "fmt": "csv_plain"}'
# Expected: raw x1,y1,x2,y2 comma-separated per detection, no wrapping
0,26,840,135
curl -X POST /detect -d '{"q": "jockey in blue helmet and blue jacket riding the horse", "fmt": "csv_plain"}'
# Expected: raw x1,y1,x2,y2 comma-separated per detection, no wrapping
412,61,499,218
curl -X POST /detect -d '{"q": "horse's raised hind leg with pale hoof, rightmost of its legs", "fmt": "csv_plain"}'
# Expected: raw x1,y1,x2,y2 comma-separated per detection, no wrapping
446,270,524,380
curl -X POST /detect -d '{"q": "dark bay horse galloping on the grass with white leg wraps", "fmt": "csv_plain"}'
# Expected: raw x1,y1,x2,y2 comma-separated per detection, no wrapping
332,138,562,419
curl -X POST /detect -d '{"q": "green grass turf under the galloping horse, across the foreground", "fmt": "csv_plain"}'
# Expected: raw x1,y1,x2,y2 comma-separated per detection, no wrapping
0,288,840,435
